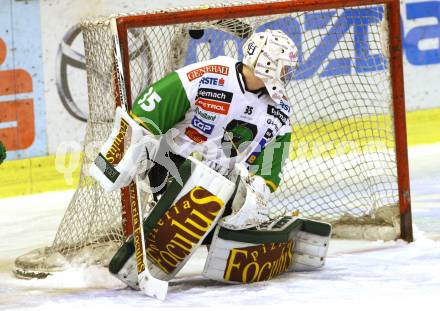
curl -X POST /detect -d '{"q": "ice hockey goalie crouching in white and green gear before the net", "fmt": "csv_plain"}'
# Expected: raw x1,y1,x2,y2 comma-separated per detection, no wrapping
90,30,331,288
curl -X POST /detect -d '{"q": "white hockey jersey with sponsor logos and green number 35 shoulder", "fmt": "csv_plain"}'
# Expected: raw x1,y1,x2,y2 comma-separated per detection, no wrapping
132,56,291,190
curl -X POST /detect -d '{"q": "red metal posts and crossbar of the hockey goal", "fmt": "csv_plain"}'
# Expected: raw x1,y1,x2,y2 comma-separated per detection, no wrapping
115,0,413,242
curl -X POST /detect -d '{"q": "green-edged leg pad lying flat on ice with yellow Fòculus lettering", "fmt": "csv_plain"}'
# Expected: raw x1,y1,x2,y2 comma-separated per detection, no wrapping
203,216,331,283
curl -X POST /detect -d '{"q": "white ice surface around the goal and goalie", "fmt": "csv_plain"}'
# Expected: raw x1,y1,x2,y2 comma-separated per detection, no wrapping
0,144,440,311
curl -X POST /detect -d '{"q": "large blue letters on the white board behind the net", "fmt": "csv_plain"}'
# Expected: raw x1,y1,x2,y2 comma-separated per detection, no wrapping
185,1,440,71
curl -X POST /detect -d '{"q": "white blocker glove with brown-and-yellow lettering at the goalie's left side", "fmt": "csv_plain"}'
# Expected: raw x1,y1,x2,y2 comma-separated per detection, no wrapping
90,107,159,192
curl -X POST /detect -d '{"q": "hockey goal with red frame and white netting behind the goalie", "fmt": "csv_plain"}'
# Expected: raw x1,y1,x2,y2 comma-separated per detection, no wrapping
14,0,412,277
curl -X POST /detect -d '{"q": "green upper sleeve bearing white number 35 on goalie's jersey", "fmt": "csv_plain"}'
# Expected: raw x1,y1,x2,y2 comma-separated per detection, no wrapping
131,72,190,135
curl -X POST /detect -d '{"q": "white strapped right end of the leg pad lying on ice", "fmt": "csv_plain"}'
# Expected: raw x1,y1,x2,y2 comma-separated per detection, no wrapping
291,219,331,272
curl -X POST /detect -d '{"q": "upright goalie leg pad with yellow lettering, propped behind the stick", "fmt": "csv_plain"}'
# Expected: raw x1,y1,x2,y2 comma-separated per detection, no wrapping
109,157,235,288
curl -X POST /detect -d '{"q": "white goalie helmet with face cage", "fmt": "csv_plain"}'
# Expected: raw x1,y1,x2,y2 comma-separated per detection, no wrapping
243,30,298,103
